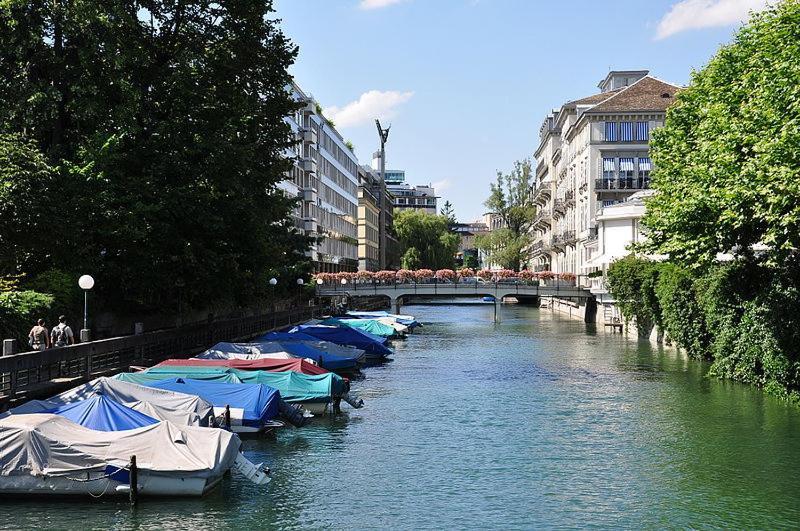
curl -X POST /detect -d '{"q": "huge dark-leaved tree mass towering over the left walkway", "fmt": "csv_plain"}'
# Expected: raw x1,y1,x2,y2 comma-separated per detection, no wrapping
0,0,307,307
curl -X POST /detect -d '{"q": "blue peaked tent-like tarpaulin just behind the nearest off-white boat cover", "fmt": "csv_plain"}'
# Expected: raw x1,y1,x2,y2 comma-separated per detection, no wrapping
49,395,158,431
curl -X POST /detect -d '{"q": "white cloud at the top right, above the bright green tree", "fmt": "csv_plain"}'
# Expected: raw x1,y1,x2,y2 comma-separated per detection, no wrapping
656,0,767,39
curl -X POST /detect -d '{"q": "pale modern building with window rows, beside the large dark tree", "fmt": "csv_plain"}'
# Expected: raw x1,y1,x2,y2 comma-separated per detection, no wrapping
281,84,359,272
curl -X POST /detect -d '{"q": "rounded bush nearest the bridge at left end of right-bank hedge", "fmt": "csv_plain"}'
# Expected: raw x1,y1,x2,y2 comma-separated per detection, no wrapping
607,255,661,337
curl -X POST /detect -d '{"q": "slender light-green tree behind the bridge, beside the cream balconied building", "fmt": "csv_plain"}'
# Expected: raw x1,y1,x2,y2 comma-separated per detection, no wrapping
477,159,536,271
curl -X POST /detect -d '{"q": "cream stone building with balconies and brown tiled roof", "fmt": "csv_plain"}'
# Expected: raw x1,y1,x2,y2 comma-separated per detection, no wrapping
530,70,679,282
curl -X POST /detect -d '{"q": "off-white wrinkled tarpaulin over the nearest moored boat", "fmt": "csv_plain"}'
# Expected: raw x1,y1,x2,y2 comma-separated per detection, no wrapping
0,413,241,478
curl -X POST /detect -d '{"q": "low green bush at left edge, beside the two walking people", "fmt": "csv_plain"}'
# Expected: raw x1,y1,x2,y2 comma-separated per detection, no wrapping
0,291,54,344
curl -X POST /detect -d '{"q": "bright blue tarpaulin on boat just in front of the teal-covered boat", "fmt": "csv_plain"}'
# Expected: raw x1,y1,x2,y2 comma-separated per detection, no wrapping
147,378,281,428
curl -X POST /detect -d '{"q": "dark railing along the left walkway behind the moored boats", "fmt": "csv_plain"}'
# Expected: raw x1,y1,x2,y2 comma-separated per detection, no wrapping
0,306,322,403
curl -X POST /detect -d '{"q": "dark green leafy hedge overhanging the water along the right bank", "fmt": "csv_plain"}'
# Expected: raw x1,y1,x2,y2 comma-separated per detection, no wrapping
607,255,800,403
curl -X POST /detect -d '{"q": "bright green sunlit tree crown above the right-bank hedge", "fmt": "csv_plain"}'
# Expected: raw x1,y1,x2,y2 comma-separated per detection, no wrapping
643,0,800,268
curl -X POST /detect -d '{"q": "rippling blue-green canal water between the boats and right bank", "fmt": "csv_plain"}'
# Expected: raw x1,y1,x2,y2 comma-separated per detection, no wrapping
0,306,800,529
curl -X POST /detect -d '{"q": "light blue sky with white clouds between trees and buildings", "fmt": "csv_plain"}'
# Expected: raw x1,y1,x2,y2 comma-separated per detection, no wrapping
275,0,766,222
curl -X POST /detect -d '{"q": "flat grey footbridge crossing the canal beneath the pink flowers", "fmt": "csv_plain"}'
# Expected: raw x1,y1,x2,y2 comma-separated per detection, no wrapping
317,280,596,319
